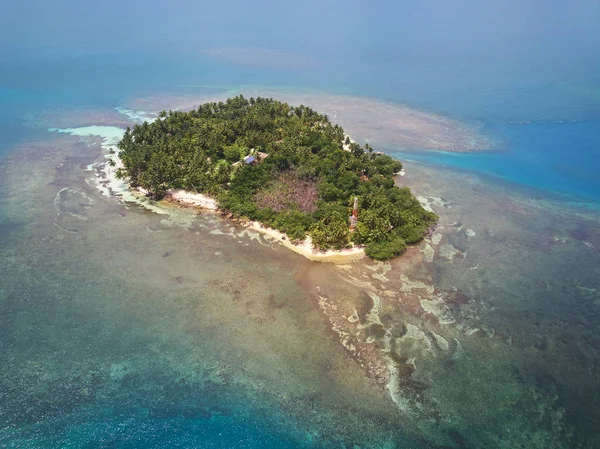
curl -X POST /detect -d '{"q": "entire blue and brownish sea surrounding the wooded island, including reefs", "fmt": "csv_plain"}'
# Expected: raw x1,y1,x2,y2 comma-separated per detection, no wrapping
0,0,600,449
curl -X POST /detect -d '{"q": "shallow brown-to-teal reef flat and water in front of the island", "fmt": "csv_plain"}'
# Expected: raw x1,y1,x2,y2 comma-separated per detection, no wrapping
0,93,600,448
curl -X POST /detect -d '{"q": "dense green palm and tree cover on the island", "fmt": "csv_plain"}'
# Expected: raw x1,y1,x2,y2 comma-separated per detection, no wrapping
119,96,437,260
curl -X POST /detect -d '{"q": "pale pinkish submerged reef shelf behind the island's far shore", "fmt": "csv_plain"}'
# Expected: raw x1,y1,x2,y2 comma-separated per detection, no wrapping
125,86,494,154
